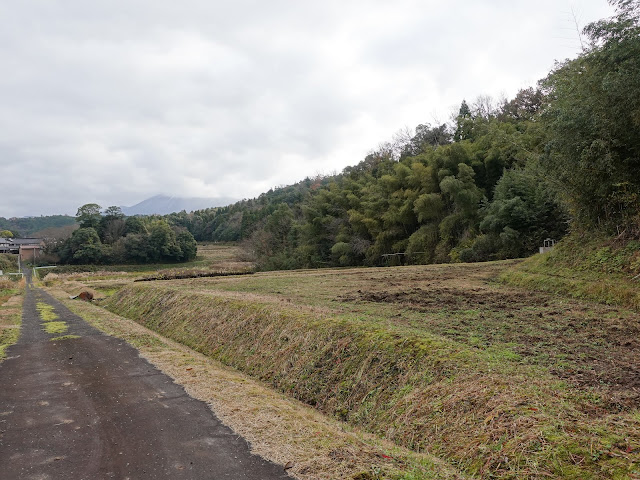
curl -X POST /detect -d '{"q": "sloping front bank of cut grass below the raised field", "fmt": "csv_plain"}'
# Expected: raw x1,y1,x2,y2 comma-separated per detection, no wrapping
106,284,640,479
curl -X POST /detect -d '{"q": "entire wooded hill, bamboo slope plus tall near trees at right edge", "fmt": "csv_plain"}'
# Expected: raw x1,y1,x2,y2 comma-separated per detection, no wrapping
169,0,640,269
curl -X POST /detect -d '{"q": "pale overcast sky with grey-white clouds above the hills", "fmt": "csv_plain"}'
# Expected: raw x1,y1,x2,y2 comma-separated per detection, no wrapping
0,0,612,217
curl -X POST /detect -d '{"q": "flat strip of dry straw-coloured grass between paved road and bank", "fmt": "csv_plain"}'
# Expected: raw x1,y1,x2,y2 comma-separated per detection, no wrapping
51,289,465,480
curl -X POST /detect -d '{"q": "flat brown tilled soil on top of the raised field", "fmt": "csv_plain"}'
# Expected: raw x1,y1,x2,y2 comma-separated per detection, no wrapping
338,269,640,410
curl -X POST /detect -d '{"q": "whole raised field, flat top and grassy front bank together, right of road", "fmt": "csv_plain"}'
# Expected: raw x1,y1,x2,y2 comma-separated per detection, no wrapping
94,263,640,479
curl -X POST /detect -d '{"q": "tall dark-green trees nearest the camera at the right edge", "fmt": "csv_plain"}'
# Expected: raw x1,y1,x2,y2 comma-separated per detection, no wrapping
542,0,640,237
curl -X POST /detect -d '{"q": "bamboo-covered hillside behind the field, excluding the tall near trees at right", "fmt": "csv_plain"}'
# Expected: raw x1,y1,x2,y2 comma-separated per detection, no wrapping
166,94,567,268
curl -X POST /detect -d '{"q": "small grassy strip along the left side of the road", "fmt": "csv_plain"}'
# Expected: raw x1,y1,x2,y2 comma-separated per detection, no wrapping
0,254,24,361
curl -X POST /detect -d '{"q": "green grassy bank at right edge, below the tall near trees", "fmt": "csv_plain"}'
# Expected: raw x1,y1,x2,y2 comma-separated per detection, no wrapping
501,234,640,310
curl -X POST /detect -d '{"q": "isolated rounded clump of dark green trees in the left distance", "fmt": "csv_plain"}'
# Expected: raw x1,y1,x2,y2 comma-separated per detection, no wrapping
52,203,197,264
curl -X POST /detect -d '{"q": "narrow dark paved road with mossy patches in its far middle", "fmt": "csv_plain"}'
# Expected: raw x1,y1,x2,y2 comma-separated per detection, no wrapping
0,278,289,480
